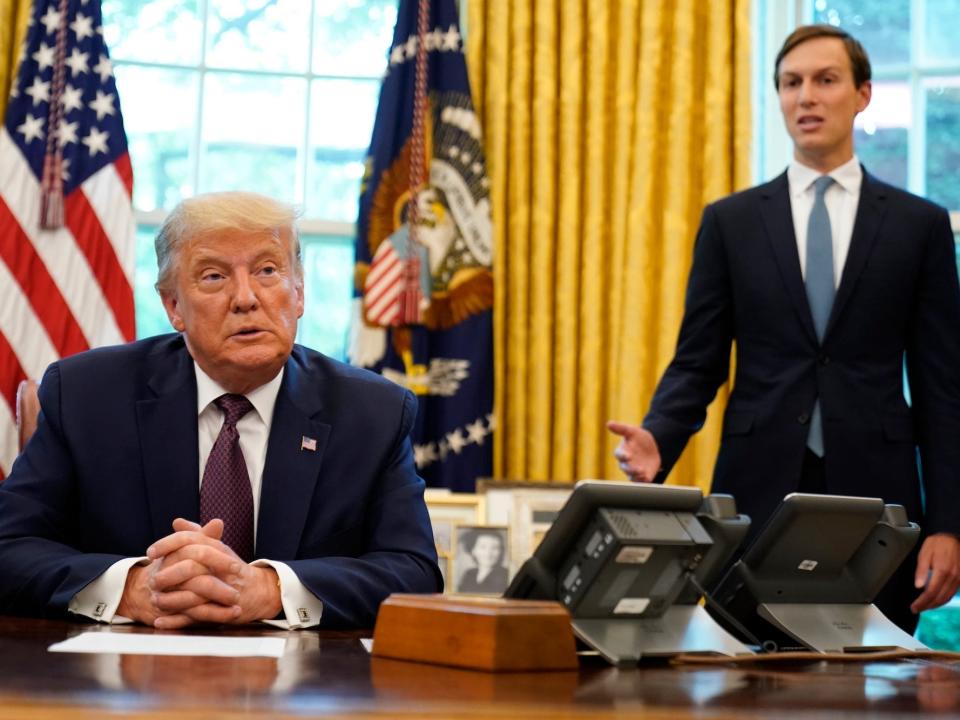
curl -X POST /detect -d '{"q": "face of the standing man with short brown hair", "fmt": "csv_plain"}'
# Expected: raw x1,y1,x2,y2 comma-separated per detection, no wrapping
779,37,871,173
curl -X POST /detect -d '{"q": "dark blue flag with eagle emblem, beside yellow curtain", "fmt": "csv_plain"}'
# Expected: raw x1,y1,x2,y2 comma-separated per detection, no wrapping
350,0,495,492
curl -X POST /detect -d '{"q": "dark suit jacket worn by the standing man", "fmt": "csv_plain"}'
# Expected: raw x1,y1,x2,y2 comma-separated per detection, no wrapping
643,172,960,533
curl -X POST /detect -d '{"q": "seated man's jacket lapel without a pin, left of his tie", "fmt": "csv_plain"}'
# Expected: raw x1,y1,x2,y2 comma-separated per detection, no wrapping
137,339,200,538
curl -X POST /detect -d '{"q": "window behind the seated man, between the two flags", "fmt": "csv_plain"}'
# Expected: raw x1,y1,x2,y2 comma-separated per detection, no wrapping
103,0,396,358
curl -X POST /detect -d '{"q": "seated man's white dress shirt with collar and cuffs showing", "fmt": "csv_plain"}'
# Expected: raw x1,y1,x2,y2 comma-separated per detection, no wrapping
70,363,323,629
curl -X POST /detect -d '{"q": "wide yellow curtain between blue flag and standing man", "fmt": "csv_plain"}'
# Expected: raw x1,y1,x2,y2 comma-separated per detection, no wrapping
467,0,750,488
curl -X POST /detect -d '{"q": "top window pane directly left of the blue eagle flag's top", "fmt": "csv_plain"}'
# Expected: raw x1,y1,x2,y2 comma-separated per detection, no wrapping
313,0,397,77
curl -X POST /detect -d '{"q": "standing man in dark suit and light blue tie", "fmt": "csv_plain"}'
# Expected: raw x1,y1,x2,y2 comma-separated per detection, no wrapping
608,25,960,631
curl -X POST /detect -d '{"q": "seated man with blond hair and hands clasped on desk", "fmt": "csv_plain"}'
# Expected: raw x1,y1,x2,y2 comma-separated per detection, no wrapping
0,193,442,629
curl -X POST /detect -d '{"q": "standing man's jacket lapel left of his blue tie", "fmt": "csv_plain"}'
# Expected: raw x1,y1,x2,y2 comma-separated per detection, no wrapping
760,173,817,342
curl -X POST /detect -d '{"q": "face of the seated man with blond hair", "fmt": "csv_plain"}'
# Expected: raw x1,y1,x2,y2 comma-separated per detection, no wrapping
161,230,303,393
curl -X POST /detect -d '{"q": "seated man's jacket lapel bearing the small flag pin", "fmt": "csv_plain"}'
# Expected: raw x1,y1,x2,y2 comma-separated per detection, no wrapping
257,349,330,558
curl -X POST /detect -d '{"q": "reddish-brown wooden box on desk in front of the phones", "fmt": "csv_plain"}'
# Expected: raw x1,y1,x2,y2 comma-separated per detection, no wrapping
373,594,577,671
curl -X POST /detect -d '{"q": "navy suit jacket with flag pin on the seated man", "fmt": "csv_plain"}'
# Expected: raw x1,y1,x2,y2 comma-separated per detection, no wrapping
0,335,442,627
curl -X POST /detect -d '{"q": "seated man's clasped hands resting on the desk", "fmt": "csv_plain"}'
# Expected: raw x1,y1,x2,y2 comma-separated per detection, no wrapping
117,518,282,630
